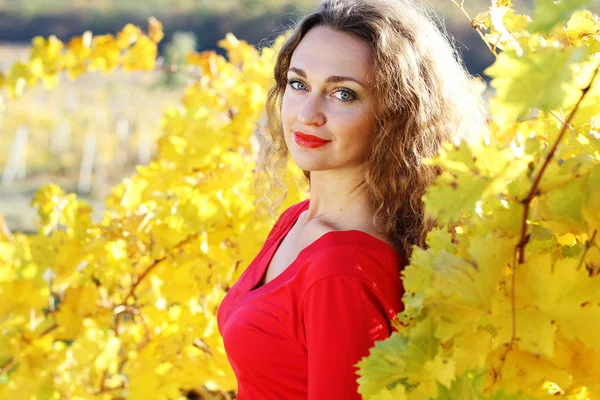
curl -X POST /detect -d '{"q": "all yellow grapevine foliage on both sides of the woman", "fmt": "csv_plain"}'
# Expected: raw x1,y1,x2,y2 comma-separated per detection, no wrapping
0,0,600,400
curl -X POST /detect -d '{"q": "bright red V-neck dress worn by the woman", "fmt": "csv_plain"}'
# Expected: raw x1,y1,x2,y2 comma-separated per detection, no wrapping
217,200,404,400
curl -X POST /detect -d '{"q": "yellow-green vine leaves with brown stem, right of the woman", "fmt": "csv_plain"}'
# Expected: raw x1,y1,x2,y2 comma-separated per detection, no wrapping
359,0,600,400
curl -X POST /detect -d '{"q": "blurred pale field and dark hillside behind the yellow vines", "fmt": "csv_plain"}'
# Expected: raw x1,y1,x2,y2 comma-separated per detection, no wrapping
0,0,532,232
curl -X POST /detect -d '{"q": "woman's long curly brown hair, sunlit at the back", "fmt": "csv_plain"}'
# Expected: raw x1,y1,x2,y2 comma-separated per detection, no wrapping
253,0,486,260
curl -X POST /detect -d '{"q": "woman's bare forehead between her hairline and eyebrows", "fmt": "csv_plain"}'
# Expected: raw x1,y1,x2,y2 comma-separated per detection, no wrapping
290,26,372,82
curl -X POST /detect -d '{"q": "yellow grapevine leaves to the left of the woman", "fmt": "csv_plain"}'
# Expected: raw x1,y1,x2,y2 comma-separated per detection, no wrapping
0,20,305,399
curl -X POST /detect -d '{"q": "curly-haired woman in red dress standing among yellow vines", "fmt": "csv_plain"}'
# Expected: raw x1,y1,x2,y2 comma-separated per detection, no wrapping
218,0,483,400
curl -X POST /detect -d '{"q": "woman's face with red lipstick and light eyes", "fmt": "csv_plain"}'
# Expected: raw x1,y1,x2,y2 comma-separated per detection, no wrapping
281,26,374,171
